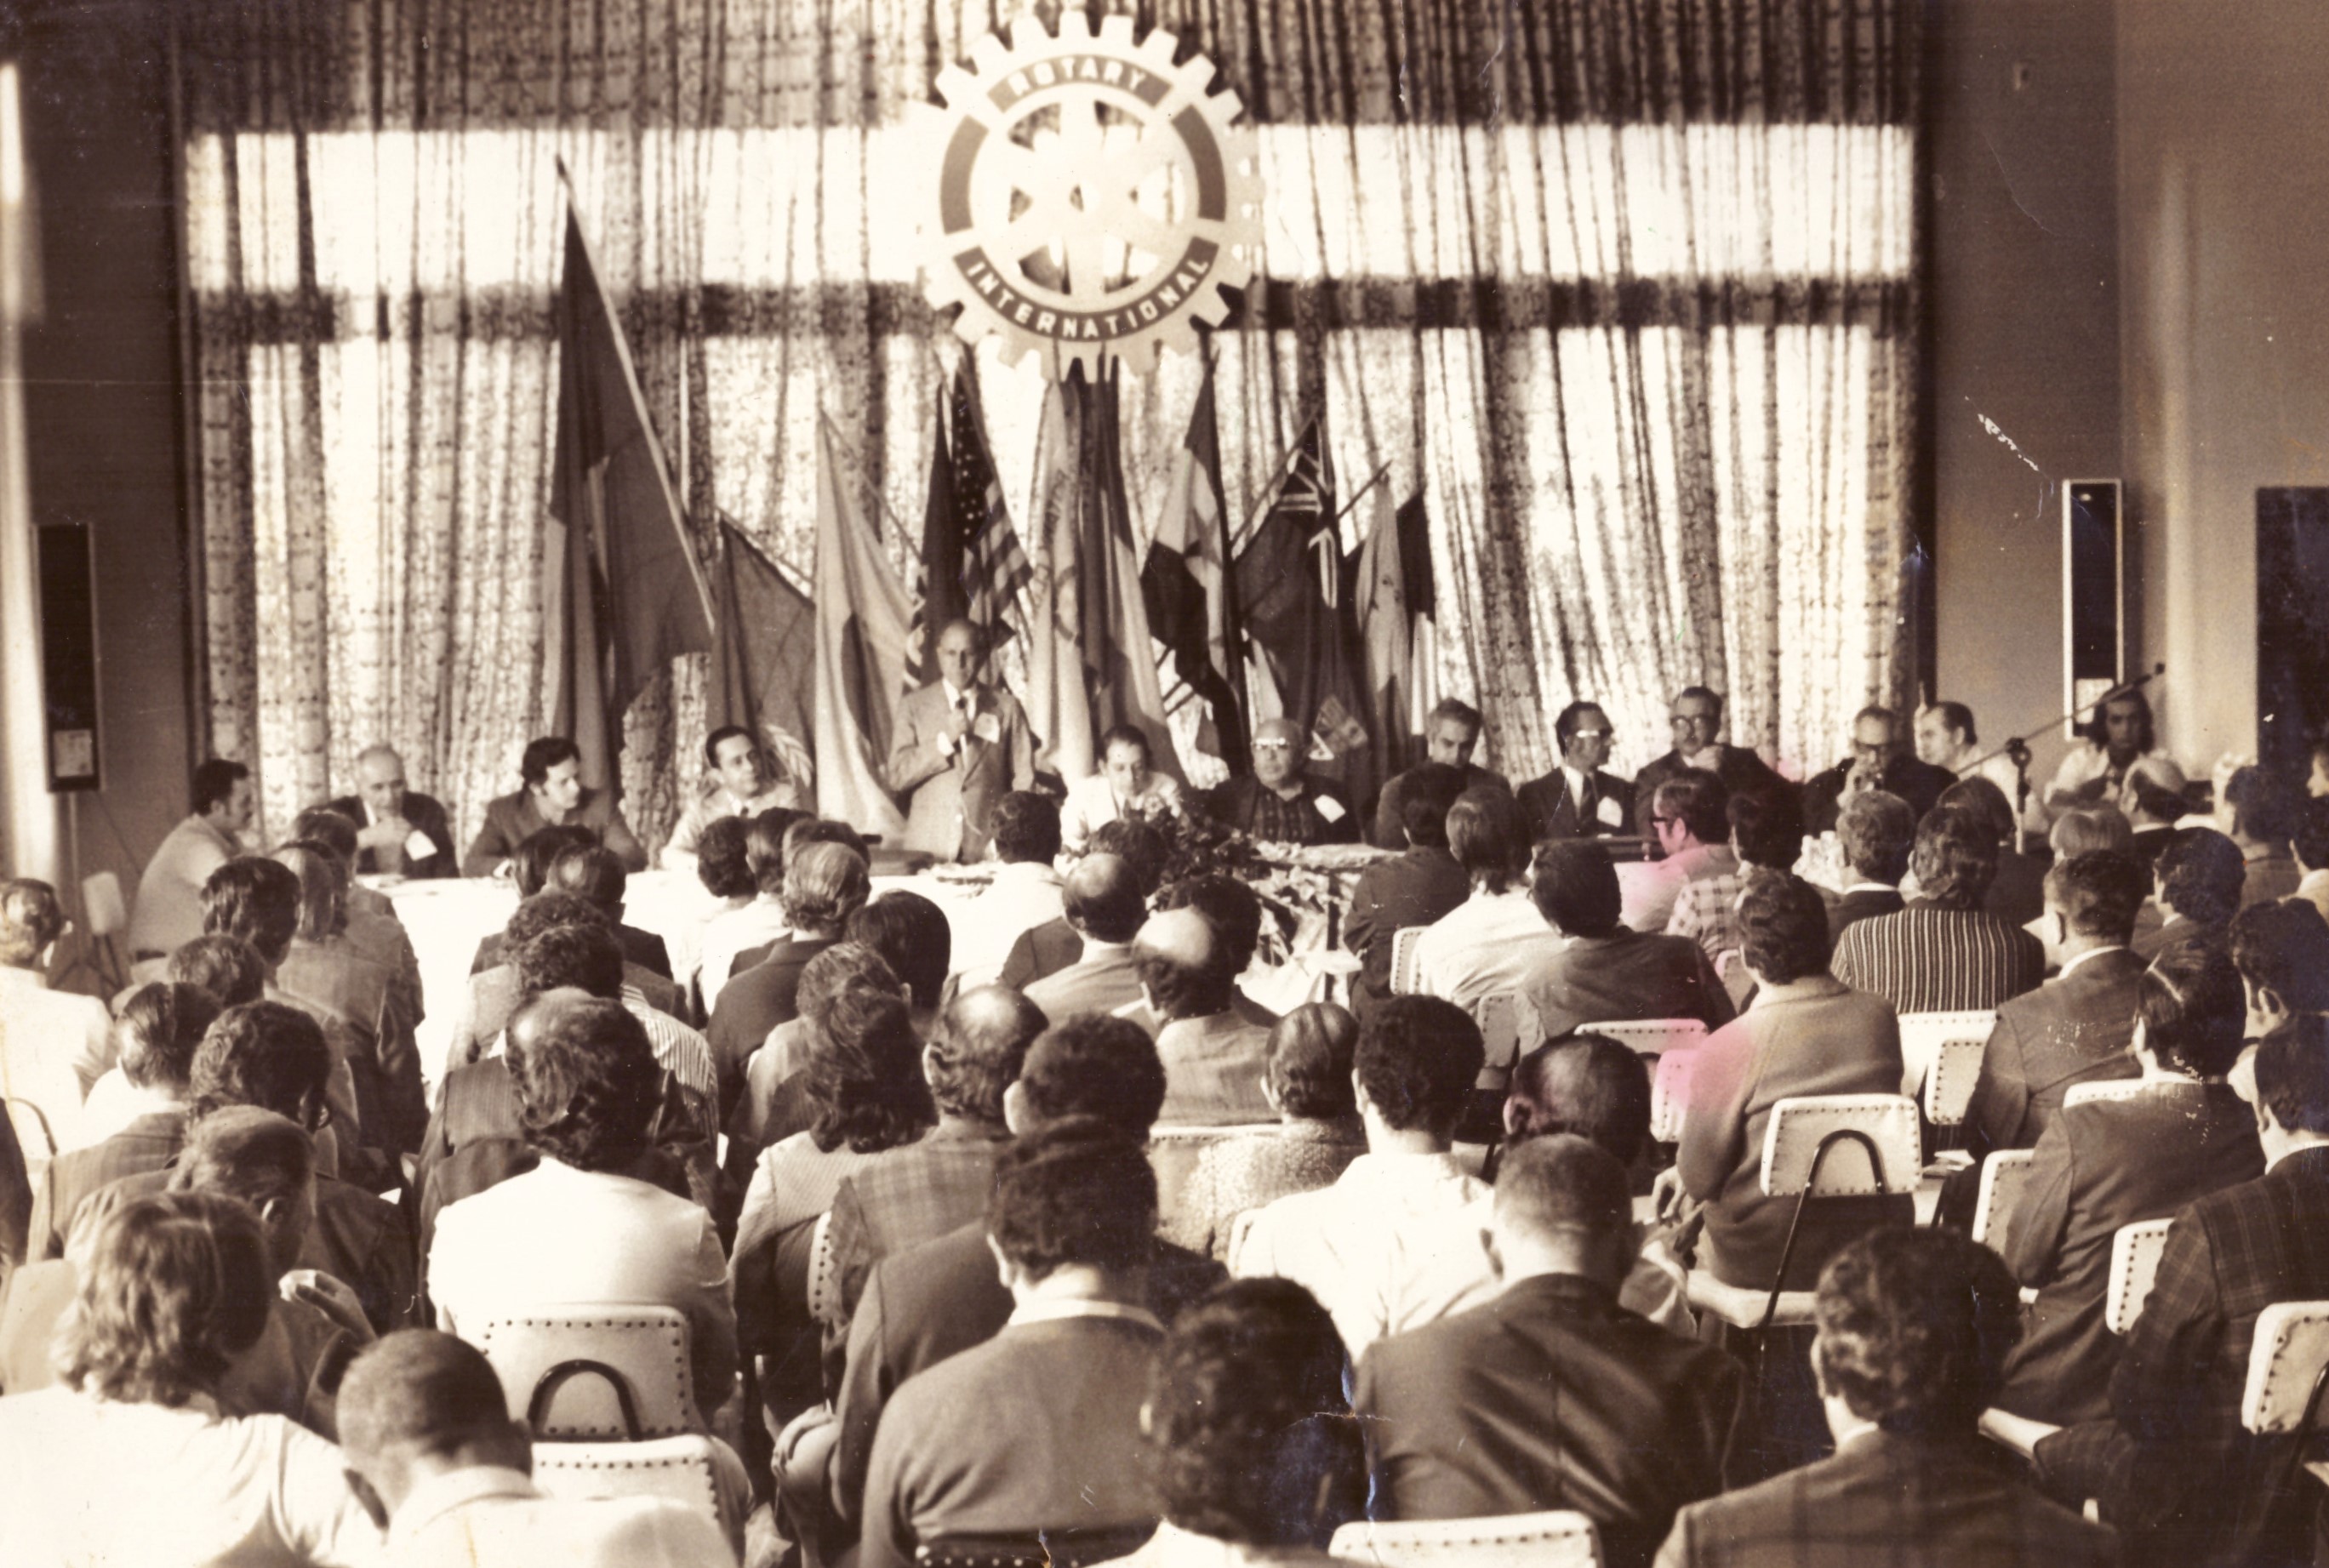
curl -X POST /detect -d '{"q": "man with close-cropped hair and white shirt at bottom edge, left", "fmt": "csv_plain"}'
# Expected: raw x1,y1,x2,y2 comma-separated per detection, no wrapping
340,1328,736,1568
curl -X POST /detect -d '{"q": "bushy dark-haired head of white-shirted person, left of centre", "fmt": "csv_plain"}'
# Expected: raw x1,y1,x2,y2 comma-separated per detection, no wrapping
503,997,664,1172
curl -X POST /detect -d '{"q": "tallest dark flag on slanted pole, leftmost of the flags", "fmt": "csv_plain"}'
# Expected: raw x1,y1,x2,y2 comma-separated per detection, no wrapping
543,180,713,788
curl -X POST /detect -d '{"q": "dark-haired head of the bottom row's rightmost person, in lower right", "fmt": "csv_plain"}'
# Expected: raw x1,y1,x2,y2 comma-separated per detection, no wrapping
1812,1225,2022,1440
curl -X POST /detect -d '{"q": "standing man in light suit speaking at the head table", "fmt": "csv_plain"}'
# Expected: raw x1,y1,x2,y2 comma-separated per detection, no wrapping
885,619,1034,860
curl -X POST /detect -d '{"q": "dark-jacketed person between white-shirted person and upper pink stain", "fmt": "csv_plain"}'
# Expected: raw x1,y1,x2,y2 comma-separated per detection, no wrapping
1521,841,1738,1041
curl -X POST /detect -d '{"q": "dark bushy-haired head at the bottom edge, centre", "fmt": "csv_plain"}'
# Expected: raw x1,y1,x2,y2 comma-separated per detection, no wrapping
1148,1277,1367,1547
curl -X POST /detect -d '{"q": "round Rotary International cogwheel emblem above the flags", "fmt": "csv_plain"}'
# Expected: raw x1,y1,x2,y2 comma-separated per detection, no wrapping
920,9,1262,379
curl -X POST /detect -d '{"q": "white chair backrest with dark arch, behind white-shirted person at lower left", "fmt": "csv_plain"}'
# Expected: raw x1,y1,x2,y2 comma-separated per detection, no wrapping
461,1303,696,1440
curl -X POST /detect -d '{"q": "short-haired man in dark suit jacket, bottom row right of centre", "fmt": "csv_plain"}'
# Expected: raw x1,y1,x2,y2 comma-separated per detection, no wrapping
1353,1135,1747,1568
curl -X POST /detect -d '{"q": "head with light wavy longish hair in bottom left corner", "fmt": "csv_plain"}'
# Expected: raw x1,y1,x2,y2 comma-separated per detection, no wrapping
51,1193,275,1407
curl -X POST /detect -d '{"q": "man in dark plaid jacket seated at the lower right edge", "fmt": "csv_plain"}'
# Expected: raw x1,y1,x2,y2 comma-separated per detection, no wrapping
2033,1018,2329,1565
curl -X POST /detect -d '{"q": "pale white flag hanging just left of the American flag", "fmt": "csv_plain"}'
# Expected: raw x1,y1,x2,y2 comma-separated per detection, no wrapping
810,422,913,841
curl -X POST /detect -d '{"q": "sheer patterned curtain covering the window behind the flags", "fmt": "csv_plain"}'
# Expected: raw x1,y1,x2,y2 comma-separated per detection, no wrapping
181,0,1917,836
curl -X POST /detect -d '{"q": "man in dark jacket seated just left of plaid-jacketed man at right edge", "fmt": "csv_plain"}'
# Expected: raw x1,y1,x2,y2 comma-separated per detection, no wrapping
1991,949,2263,1426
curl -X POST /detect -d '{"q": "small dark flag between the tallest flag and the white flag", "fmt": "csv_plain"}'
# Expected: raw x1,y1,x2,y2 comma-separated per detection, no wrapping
704,517,818,785
